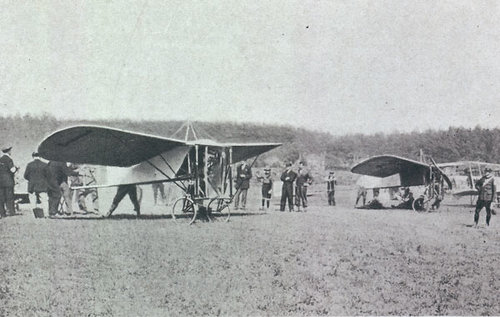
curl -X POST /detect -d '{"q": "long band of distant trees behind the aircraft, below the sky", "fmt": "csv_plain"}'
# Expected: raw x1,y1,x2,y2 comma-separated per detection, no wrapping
0,115,500,169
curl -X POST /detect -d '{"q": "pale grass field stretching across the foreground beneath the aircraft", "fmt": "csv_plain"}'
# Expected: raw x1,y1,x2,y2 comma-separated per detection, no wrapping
0,186,500,316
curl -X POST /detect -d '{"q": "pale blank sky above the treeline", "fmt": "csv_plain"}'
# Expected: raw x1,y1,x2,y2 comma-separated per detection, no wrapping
0,0,500,135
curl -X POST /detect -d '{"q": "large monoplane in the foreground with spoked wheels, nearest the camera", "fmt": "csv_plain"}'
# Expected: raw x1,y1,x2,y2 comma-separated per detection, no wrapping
38,125,281,224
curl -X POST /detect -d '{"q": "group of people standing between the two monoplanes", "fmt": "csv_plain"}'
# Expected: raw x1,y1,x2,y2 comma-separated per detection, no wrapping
234,162,337,212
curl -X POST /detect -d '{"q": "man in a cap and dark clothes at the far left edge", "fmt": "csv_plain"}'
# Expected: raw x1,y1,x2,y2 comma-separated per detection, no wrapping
0,147,19,217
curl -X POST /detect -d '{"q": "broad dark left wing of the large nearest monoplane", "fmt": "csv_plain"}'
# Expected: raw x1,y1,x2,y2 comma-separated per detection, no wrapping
38,125,186,167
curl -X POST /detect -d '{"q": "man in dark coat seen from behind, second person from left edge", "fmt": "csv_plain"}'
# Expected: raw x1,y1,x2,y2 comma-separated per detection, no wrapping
24,152,49,208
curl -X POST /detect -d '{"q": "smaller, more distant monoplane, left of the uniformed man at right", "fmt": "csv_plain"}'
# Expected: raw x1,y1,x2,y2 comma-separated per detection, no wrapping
351,155,452,211
